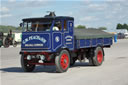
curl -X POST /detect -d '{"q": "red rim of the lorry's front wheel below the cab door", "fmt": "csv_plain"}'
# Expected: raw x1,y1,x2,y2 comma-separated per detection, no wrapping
60,54,69,70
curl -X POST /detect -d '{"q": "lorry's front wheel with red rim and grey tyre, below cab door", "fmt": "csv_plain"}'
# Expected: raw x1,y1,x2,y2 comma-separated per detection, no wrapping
55,50,70,73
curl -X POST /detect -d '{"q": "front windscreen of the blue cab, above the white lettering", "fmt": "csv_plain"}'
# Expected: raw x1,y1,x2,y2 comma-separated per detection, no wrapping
23,22,52,32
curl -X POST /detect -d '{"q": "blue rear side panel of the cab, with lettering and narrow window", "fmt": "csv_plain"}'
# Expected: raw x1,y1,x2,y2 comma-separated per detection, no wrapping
63,20,74,50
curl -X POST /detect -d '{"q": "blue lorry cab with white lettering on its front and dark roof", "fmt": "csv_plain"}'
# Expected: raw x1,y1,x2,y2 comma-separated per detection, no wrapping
21,14,74,52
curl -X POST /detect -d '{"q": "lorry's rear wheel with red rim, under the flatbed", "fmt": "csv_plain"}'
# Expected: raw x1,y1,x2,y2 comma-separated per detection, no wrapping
89,47,104,66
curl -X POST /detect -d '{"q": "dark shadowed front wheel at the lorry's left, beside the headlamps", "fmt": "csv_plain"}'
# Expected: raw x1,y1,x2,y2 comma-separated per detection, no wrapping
21,55,35,72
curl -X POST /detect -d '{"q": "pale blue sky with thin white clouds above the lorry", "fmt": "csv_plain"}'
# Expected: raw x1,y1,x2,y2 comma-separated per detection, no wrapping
0,0,128,31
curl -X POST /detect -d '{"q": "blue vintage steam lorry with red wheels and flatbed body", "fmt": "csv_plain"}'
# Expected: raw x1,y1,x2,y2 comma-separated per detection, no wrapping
20,12,112,72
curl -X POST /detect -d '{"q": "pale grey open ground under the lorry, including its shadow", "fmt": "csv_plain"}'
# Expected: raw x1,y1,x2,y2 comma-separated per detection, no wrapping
0,39,128,85
